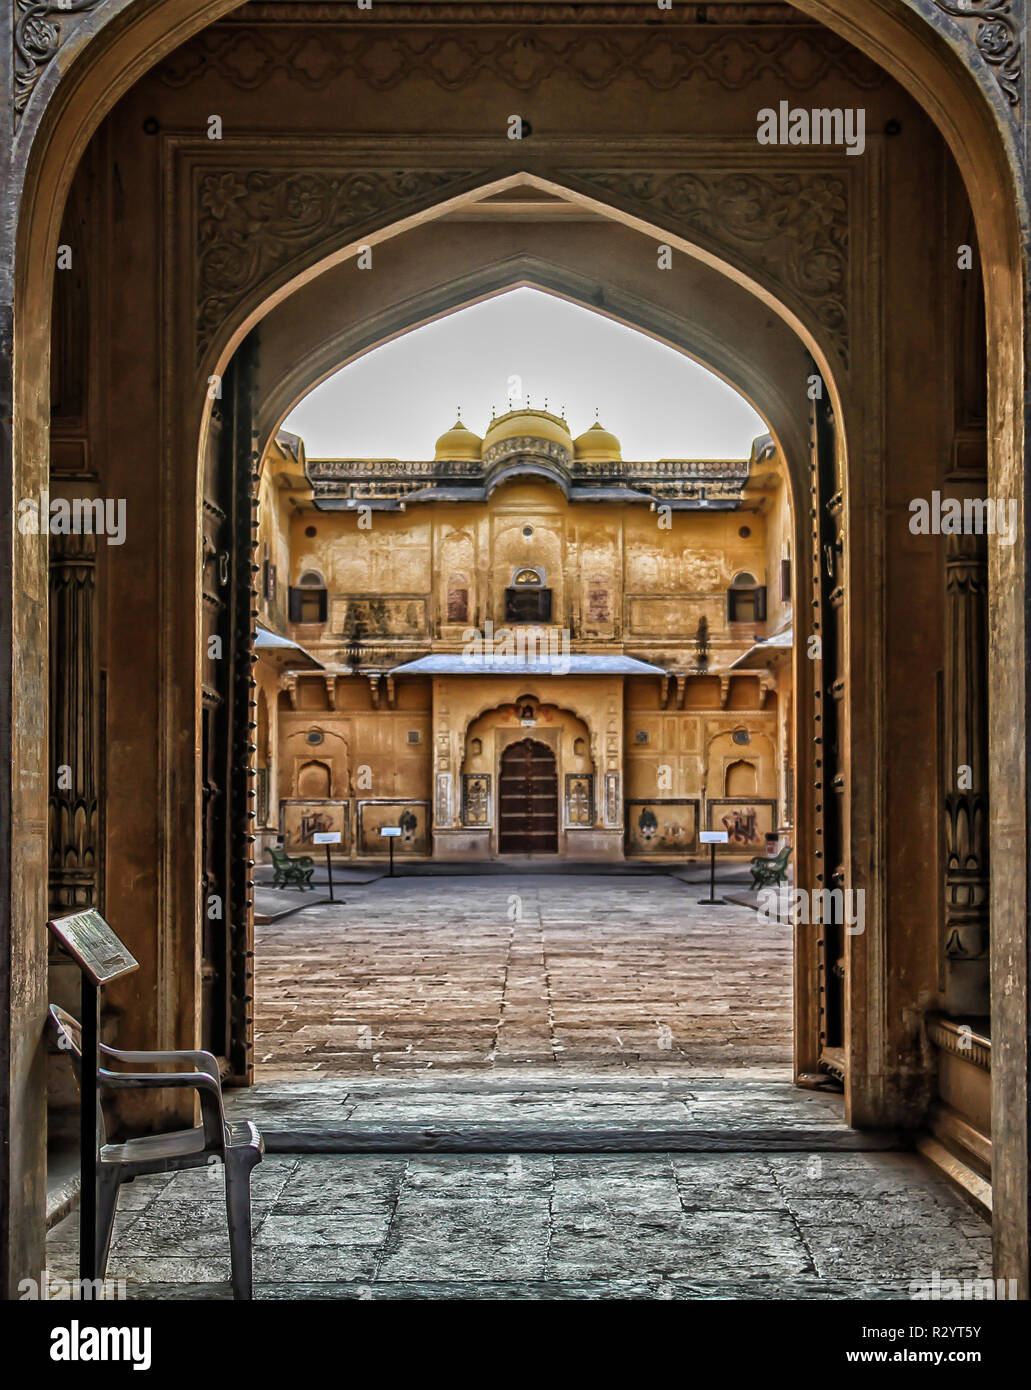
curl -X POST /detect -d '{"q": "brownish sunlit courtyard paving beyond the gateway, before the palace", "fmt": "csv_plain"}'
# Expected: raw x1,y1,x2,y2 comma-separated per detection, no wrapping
256,874,792,1077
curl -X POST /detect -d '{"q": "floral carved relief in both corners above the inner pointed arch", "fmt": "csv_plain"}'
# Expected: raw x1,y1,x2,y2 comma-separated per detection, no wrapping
195,160,849,363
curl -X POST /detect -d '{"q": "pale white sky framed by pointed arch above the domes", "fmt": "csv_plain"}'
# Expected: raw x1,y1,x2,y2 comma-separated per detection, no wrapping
285,289,766,459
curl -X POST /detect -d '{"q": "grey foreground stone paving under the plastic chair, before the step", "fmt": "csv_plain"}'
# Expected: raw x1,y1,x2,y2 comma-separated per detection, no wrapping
49,1154,991,1300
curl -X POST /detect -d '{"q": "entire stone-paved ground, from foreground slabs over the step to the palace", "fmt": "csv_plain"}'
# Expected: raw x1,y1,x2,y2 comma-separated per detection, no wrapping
49,874,991,1300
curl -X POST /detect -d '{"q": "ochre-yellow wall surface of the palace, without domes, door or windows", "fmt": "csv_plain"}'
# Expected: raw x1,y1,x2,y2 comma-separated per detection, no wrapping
257,446,791,860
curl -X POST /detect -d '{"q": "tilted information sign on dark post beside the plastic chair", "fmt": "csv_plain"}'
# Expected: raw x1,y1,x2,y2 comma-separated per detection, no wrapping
47,909,139,1280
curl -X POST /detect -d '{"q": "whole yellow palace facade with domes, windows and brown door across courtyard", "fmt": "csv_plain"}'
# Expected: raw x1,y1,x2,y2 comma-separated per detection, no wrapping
257,409,792,862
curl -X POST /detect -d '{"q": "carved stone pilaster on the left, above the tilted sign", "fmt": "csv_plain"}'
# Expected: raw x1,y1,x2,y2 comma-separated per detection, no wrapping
49,535,100,912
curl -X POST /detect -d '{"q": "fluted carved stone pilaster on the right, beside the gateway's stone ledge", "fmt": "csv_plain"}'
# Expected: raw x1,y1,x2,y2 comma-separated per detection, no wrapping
943,489,988,1015
